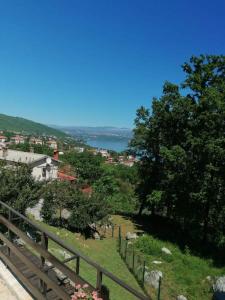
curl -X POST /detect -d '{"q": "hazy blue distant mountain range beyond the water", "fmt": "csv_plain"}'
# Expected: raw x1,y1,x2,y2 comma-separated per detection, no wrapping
51,125,132,139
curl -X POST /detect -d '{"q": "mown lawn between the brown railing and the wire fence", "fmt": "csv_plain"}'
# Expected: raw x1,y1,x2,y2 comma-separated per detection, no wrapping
37,223,142,300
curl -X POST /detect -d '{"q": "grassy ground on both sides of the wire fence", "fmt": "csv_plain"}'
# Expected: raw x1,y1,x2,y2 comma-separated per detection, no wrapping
36,216,225,300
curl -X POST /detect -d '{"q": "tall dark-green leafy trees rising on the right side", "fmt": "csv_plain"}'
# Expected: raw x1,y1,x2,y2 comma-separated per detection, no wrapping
131,55,225,246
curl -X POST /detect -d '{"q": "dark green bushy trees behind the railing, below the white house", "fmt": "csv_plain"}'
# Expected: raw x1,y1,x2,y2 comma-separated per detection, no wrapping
41,181,109,234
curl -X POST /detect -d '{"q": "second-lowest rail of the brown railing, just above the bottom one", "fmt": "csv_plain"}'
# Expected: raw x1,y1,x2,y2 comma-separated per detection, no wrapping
0,233,70,300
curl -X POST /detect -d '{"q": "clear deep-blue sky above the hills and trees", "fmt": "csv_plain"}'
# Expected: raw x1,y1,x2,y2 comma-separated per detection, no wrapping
0,0,225,127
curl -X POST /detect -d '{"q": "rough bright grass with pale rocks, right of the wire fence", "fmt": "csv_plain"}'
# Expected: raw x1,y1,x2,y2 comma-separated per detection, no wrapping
136,235,225,300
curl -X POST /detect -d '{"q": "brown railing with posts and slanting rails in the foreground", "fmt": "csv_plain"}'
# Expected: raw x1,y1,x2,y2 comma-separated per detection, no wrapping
0,201,150,300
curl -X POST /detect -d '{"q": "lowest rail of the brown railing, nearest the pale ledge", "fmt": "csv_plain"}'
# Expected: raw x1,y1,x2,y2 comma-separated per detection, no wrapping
0,251,46,300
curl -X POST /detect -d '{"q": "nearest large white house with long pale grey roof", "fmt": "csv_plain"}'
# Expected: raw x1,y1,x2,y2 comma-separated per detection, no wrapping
0,147,60,181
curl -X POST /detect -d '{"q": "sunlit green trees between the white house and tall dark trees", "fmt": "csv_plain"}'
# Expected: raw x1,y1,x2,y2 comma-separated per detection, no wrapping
61,151,138,213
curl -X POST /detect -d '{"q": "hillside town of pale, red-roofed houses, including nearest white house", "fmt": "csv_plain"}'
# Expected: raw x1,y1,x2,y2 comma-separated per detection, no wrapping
0,130,137,182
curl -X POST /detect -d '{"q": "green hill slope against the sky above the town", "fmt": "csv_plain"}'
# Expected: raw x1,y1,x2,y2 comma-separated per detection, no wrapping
0,114,66,137
